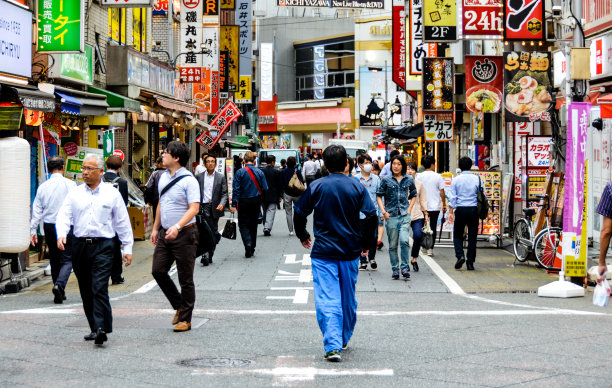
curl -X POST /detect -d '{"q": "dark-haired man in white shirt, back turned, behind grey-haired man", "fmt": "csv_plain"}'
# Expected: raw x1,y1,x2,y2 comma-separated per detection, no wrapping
30,156,76,304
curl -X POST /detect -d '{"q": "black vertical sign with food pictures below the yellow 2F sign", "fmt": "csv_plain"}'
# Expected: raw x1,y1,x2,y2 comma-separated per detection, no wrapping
423,58,454,111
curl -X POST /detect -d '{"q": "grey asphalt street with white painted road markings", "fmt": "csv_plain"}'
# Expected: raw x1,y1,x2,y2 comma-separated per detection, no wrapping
0,217,612,387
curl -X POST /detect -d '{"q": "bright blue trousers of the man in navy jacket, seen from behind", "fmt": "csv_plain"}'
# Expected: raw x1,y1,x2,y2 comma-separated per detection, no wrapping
311,257,359,352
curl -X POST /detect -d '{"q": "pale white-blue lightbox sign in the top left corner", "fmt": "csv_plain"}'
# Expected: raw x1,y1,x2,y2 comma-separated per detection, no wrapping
0,1,32,78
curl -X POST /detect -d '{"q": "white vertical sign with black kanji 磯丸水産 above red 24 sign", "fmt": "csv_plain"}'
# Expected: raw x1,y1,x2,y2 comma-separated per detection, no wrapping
179,0,205,67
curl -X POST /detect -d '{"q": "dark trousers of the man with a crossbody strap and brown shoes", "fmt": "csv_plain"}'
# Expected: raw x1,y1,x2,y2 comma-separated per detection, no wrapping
151,226,198,322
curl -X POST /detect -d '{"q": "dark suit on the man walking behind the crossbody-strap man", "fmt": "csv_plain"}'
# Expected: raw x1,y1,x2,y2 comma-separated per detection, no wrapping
196,171,227,265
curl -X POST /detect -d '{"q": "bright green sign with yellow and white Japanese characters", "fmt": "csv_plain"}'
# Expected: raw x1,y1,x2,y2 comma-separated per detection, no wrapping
36,0,85,53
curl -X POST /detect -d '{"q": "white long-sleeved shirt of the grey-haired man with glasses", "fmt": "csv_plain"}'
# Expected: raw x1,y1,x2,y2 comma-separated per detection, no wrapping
55,181,134,255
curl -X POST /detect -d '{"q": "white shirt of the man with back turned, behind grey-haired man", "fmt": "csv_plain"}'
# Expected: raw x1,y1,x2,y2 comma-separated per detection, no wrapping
30,172,76,234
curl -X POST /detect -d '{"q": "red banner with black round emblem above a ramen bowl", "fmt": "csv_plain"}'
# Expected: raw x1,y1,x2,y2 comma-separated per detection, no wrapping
465,55,504,113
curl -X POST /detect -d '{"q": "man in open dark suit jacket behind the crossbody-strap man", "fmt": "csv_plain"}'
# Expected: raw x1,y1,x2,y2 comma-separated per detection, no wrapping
196,155,227,266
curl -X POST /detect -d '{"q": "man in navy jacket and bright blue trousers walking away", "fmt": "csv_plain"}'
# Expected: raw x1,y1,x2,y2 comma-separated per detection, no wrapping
294,145,377,362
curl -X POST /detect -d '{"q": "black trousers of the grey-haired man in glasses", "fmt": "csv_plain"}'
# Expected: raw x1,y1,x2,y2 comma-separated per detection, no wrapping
72,238,115,333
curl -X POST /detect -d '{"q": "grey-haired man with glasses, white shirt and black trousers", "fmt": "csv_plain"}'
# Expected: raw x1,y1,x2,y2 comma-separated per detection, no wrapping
55,154,134,345
